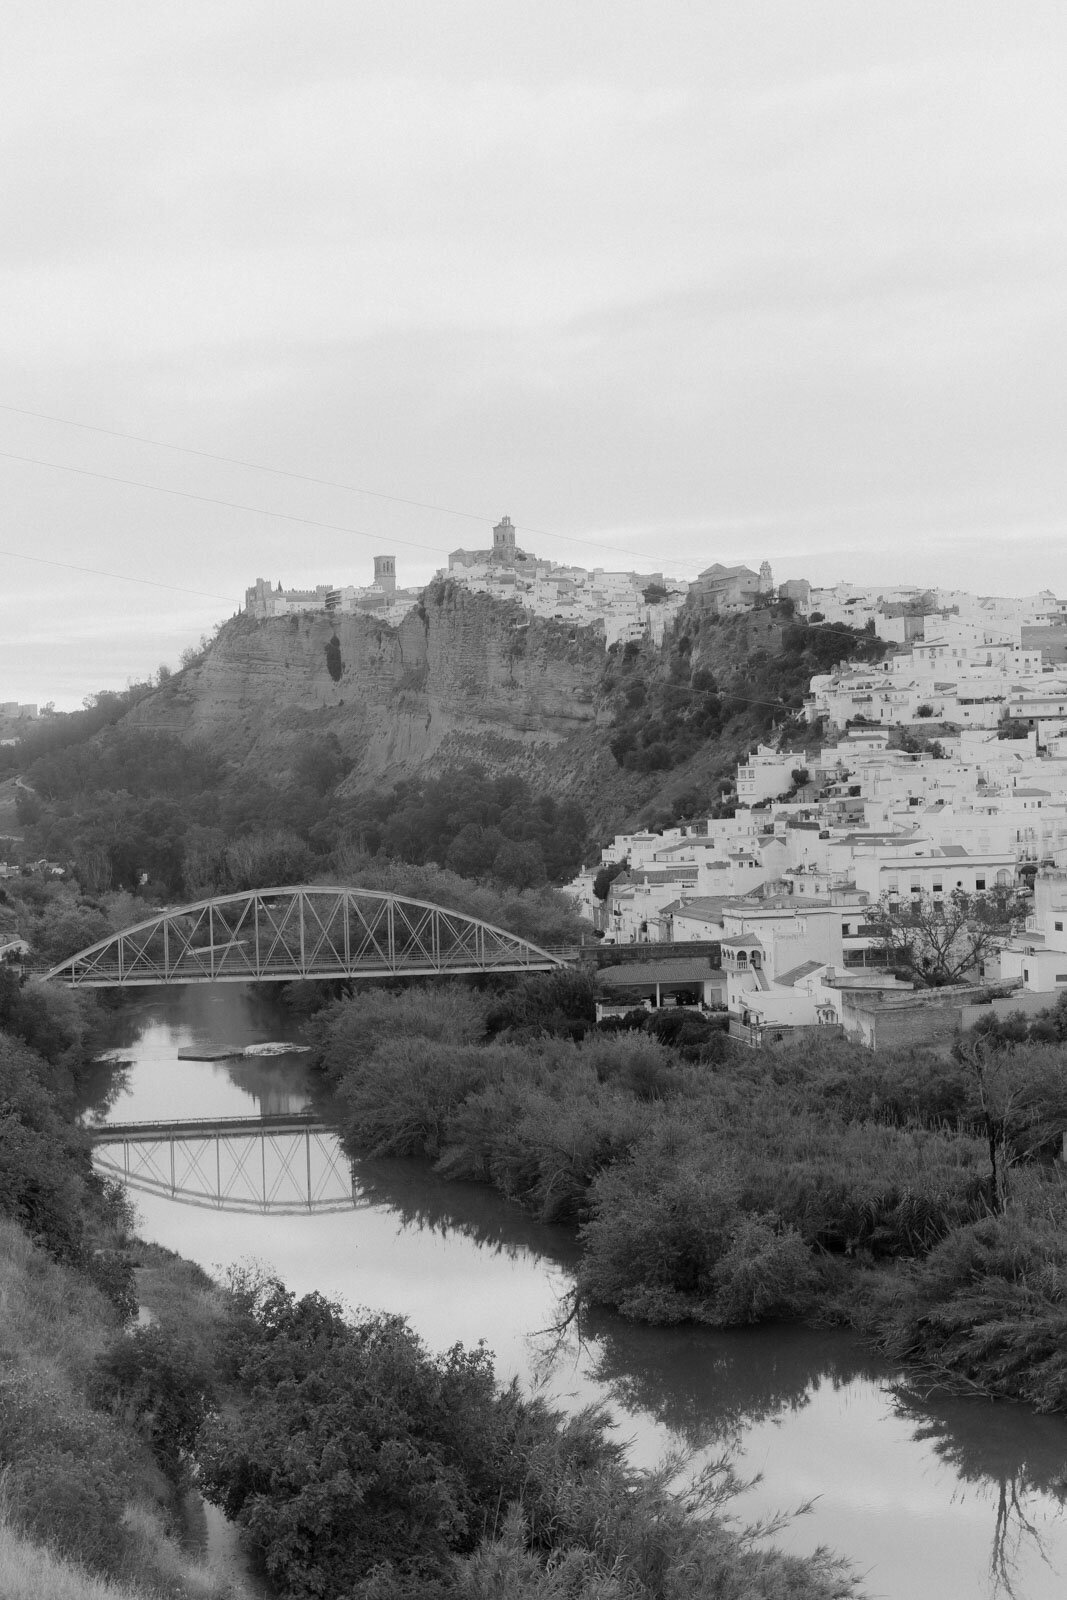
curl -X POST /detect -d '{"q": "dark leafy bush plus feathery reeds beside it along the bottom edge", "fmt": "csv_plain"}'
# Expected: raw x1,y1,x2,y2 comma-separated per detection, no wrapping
200,1280,854,1600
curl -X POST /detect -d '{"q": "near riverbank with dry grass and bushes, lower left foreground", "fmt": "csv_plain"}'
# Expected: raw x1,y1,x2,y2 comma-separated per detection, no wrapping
0,1011,857,1600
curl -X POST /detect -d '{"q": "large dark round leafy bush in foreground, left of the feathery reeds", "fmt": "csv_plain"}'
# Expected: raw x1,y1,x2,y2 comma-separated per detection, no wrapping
198,1280,517,1600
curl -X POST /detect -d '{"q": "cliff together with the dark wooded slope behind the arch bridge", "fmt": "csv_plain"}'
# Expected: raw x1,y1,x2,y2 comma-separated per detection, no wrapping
2,592,885,921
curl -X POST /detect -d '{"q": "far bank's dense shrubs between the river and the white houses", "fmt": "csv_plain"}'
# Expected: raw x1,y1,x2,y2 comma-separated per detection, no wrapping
315,979,1067,1413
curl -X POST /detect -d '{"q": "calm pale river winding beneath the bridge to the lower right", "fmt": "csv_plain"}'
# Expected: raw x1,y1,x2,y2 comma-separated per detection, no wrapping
81,987,1067,1600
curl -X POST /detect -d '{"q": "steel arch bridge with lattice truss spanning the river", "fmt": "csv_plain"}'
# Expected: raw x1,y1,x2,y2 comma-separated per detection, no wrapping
45,885,569,989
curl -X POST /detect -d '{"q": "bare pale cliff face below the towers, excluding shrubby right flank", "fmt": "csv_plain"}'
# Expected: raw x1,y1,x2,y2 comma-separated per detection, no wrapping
130,582,613,792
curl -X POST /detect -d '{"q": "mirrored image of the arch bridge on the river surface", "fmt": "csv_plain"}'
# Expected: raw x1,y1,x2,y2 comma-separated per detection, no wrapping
90,1115,358,1216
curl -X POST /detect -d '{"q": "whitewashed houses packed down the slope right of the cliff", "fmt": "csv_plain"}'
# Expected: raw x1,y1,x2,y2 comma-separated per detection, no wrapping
574,563,1067,1045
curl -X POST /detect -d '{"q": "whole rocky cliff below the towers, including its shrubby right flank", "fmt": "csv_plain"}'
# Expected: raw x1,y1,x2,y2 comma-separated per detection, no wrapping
126,581,844,834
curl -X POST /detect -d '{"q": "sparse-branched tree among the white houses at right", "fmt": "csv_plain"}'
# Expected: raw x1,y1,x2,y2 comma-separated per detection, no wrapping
869,890,1017,989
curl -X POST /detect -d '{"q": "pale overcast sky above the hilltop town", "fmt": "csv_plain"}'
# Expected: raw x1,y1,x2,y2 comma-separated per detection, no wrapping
0,0,1067,709
